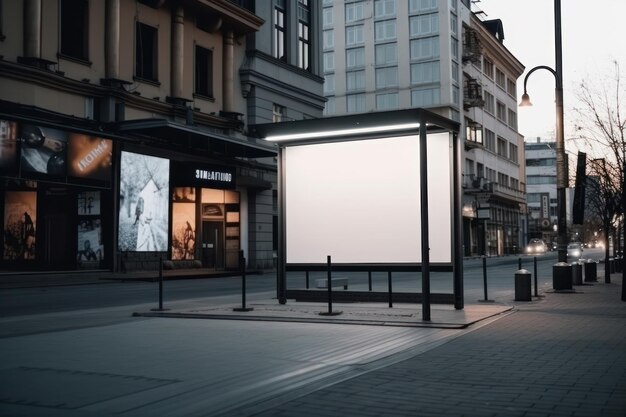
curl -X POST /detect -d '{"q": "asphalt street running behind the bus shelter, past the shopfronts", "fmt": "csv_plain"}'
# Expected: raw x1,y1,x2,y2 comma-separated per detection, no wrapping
0,249,602,317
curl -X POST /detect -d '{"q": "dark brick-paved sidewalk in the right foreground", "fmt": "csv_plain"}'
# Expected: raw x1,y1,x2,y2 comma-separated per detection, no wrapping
254,281,626,417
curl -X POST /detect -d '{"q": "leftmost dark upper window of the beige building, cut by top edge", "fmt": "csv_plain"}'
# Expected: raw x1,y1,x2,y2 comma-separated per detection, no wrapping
59,0,89,61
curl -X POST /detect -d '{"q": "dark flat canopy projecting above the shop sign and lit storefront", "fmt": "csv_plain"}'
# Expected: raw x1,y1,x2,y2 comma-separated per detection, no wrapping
114,119,277,158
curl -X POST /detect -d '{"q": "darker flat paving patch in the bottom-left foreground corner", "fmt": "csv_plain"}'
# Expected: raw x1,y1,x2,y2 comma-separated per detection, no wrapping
0,366,179,410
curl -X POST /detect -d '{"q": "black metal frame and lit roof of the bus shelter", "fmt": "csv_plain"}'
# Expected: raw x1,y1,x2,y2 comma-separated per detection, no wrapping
250,109,464,314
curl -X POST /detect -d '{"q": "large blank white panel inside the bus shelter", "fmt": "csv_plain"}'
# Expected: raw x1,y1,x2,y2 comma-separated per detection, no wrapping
284,132,453,264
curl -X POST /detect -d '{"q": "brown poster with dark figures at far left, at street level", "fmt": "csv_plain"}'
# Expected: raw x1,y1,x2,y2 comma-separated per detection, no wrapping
3,191,37,261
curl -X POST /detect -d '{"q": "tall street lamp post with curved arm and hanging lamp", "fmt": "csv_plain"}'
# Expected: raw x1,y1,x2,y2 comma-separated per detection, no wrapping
519,0,572,289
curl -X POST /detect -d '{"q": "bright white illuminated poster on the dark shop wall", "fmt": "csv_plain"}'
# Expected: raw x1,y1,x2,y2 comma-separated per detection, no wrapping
118,152,170,252
